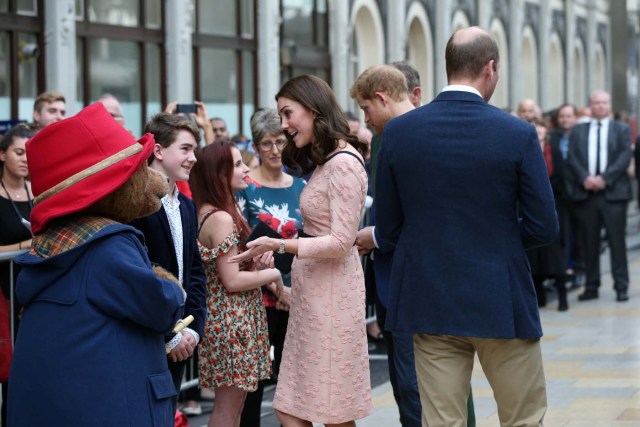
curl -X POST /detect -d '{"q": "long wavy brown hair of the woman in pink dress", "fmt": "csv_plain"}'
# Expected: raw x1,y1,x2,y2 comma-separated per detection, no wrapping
276,75,368,175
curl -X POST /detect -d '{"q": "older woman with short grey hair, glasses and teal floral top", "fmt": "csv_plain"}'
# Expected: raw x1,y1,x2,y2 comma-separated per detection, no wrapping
237,109,306,426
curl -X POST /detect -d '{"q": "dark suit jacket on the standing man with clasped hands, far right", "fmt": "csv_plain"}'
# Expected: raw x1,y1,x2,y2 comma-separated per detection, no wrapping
567,120,633,202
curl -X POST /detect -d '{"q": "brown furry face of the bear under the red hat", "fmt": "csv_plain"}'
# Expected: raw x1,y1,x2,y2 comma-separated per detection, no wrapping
83,162,169,224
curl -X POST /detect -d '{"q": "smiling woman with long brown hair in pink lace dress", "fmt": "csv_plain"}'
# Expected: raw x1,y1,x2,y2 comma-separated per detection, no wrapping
232,76,372,427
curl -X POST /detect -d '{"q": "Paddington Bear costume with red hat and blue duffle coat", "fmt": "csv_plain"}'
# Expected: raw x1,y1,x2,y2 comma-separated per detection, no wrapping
8,103,184,427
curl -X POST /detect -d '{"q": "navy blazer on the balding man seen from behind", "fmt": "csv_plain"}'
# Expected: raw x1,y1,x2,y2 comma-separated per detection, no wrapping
376,91,558,339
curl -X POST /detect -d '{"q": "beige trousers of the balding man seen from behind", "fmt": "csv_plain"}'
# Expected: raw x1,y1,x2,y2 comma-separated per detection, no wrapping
413,334,547,427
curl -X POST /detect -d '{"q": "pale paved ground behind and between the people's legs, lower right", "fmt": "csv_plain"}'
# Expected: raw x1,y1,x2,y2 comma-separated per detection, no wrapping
358,249,640,427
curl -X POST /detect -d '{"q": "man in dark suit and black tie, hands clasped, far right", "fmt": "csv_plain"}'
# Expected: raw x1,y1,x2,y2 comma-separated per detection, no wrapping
567,90,633,302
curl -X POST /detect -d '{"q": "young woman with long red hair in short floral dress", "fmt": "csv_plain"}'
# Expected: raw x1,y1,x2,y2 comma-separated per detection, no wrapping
189,141,282,427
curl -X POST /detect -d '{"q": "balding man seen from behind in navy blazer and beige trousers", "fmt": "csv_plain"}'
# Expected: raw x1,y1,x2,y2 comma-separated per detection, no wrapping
376,27,558,427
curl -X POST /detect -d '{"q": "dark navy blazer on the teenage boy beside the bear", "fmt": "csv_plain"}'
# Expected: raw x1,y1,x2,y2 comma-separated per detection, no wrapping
131,193,207,338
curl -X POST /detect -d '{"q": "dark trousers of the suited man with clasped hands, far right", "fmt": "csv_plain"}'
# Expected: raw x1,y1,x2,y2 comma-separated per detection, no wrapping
574,193,629,291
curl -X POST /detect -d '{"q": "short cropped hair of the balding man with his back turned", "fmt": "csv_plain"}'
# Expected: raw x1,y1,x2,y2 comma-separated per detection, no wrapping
445,32,500,78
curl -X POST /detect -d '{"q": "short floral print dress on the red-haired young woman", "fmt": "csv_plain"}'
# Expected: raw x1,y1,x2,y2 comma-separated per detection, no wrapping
198,218,271,392
